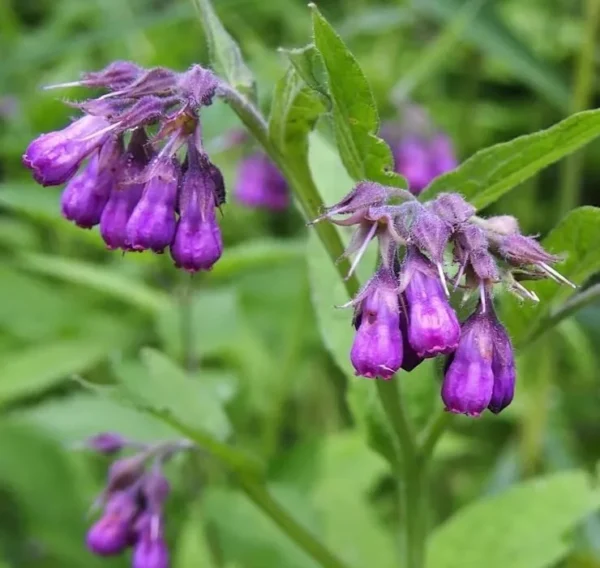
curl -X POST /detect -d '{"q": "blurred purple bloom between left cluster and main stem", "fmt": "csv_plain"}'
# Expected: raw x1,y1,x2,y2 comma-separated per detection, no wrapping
235,153,290,211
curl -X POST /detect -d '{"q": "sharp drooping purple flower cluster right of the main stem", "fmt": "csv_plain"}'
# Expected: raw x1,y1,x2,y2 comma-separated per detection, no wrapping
315,182,573,416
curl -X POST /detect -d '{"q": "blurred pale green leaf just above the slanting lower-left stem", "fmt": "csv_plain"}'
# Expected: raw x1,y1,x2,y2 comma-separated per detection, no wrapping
116,349,231,440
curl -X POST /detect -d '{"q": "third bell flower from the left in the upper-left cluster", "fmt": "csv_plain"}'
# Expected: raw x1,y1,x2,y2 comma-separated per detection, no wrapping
100,129,150,250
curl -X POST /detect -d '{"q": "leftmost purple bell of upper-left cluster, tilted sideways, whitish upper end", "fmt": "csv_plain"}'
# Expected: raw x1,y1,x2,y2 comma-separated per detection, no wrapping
23,115,109,186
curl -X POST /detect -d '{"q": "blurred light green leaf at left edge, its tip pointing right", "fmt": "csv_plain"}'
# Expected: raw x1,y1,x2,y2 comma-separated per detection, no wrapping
0,329,129,406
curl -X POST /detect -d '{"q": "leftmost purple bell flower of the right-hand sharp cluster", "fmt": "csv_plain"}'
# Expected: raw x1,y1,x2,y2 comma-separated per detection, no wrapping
350,267,402,379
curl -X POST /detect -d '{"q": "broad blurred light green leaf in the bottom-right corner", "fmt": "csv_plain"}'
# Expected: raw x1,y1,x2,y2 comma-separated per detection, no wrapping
427,471,600,568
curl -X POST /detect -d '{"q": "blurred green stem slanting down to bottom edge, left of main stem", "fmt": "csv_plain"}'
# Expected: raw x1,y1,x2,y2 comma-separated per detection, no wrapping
241,479,347,568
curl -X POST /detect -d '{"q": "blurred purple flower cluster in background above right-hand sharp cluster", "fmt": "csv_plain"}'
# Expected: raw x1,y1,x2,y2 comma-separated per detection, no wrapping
382,105,458,195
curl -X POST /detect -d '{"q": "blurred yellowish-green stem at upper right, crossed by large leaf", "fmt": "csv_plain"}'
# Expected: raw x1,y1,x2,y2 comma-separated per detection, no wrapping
558,0,600,217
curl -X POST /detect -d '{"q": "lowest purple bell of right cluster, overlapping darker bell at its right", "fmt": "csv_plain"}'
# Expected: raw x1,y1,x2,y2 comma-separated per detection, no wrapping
442,304,494,416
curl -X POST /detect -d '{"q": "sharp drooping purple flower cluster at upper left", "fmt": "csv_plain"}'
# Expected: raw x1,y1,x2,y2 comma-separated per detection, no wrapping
23,61,225,272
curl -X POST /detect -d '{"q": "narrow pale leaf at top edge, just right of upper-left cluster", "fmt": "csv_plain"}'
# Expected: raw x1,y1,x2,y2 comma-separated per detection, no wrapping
193,0,256,99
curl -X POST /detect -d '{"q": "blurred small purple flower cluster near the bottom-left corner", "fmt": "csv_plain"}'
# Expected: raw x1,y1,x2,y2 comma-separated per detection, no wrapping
86,432,191,568
